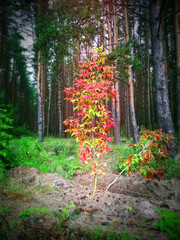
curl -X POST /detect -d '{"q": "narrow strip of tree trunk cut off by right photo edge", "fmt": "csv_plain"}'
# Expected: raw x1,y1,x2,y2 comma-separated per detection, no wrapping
174,0,180,139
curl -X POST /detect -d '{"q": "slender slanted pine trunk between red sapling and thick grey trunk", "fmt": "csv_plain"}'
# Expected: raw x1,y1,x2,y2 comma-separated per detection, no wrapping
123,0,139,143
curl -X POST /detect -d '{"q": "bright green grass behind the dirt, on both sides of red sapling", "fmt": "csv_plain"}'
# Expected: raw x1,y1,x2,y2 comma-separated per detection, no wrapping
3,136,180,179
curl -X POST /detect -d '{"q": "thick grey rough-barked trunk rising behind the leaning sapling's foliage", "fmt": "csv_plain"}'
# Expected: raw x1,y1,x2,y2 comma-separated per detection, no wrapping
149,0,176,156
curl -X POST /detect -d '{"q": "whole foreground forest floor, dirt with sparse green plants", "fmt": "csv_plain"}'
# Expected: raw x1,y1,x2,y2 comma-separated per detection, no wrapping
0,166,180,240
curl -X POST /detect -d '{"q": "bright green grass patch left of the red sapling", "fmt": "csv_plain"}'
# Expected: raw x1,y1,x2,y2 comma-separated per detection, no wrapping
7,137,87,179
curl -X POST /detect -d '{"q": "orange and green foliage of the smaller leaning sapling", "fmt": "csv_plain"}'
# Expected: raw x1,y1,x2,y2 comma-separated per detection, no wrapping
122,129,173,179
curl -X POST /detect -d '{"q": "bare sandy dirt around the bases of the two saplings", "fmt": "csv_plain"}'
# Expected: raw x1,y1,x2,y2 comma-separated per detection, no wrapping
0,166,180,240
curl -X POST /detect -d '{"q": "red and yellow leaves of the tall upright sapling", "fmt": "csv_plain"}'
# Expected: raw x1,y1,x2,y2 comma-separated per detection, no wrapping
64,47,115,182
